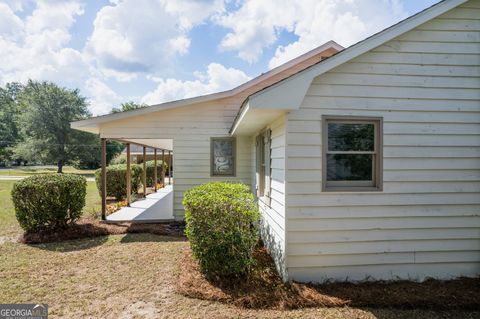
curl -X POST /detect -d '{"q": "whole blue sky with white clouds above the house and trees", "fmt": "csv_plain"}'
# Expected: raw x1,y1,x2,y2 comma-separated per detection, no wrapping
0,0,438,115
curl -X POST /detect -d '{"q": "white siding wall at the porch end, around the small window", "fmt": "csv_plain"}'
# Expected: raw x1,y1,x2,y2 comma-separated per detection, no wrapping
100,99,252,220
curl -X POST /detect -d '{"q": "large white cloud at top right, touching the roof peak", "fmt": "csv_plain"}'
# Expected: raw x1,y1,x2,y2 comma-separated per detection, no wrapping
216,0,407,68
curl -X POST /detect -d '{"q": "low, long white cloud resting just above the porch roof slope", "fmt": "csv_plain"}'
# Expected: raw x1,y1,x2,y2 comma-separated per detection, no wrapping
142,63,251,104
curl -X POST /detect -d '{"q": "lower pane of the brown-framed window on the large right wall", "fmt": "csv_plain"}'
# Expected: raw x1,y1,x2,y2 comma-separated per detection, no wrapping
327,154,373,181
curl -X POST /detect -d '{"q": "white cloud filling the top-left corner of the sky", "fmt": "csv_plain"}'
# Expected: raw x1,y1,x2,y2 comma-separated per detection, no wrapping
0,1,88,84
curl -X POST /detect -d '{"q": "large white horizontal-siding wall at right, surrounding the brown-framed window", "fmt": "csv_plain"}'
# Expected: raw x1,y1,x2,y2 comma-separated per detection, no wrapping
286,1,480,281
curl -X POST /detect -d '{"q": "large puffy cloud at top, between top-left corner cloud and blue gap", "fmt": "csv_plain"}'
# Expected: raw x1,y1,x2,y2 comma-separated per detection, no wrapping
87,0,223,81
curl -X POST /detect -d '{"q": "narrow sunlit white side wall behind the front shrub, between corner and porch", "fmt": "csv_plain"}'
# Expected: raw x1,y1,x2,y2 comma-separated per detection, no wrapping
252,116,287,280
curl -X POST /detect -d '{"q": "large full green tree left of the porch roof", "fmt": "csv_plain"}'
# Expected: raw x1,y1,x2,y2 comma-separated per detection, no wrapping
14,80,98,173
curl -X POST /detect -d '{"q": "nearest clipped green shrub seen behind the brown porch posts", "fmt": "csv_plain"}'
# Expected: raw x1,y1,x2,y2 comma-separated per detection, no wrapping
95,164,143,200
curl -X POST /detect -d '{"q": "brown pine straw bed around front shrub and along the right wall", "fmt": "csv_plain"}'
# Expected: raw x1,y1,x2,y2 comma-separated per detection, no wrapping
176,246,480,310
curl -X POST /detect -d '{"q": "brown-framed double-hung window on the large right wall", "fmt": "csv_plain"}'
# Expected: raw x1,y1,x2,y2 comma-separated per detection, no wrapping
323,117,382,191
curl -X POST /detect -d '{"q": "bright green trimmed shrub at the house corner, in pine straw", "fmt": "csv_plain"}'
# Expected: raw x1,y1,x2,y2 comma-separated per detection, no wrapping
183,182,260,277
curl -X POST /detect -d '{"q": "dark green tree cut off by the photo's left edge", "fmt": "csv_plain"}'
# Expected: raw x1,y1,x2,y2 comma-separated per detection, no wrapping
0,82,23,163
